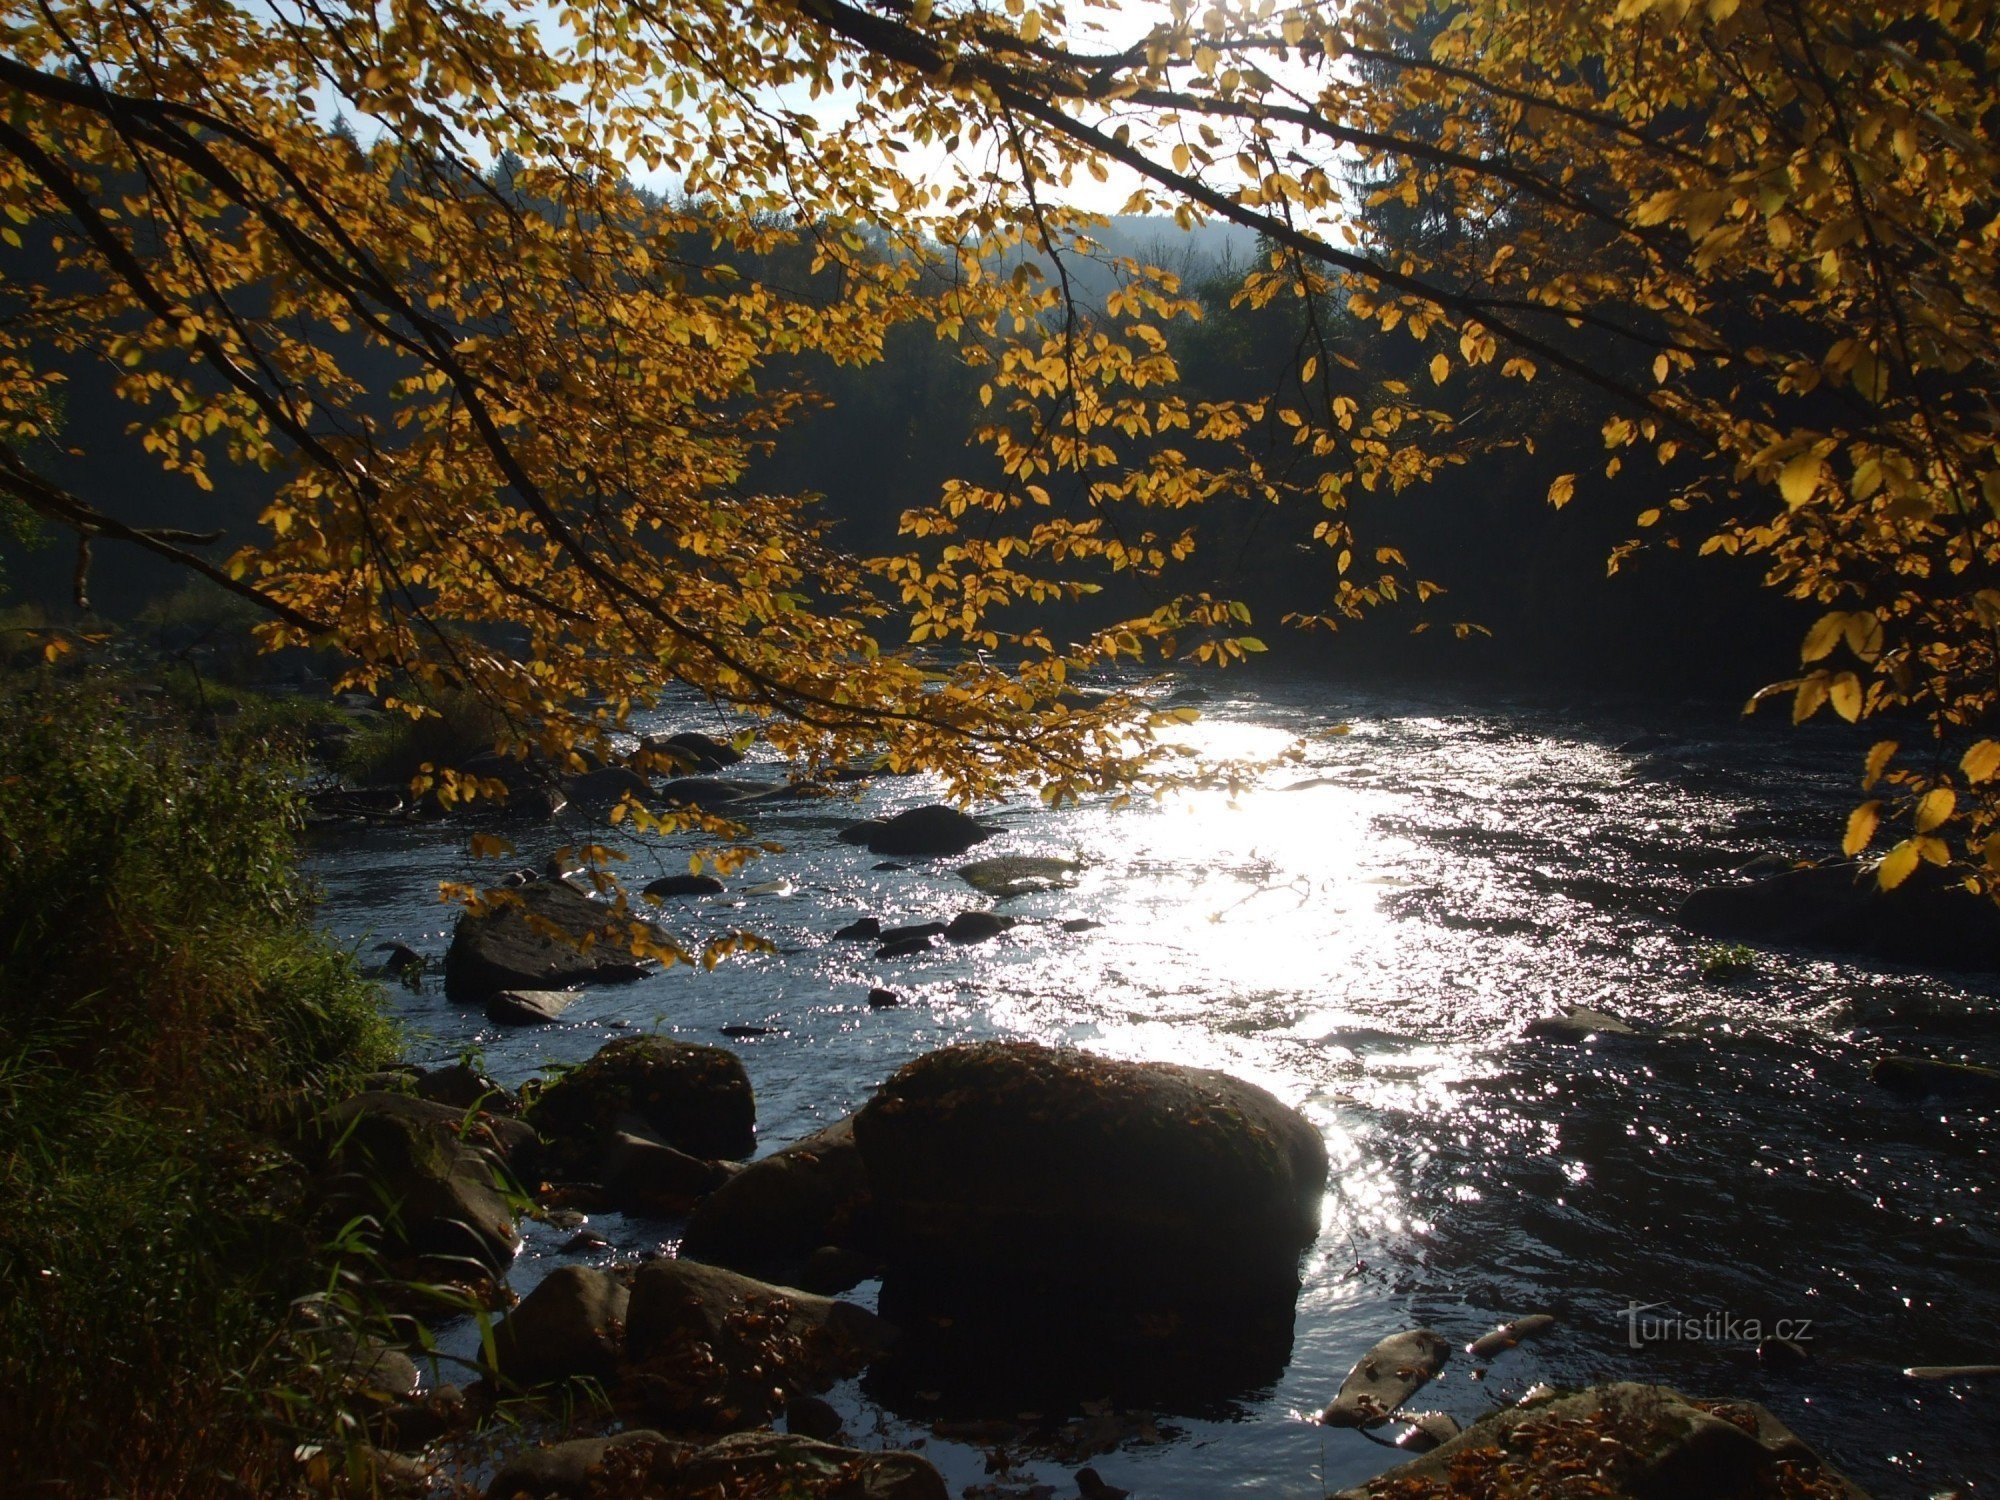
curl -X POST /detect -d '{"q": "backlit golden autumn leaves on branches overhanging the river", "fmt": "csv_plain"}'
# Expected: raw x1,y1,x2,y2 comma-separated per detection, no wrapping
11,0,2000,892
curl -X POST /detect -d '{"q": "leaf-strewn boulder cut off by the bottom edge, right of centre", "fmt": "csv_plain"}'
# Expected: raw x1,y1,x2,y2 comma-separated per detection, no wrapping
1338,1382,1868,1500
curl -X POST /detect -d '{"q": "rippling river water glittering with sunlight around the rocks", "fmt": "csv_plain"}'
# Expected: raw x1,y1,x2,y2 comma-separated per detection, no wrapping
312,680,2000,1500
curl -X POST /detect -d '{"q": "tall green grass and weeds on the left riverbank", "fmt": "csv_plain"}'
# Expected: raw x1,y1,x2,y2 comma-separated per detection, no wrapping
0,672,394,1496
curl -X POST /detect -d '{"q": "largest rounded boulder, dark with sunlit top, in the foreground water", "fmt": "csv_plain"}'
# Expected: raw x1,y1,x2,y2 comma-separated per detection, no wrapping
854,1042,1326,1306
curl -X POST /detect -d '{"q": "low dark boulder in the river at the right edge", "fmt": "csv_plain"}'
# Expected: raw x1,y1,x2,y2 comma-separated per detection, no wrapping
1674,860,2000,974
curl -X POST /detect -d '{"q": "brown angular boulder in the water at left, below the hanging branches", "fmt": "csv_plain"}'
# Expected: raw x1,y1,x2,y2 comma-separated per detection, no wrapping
444,880,650,1000
